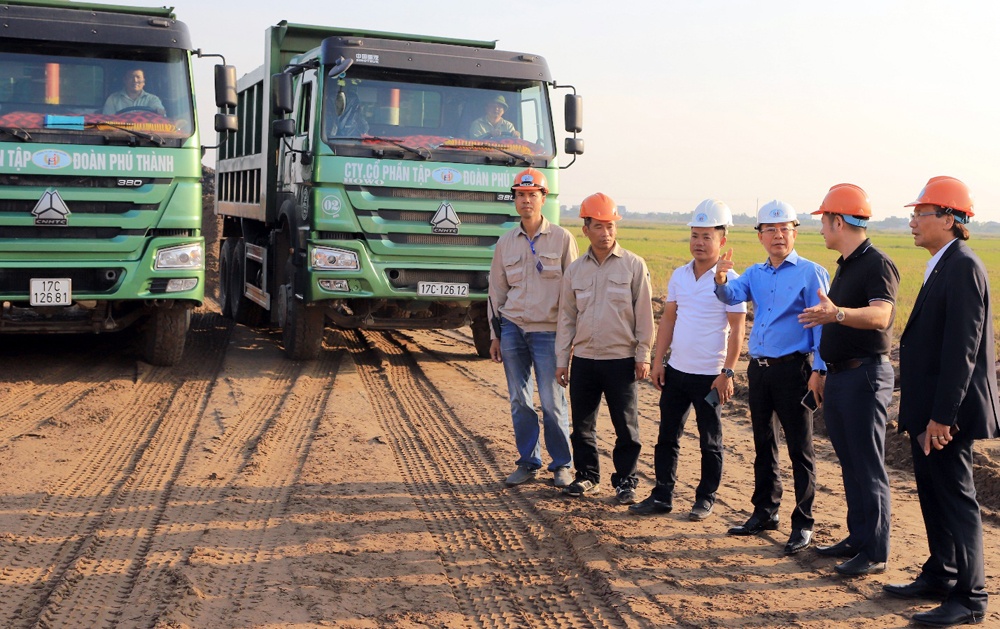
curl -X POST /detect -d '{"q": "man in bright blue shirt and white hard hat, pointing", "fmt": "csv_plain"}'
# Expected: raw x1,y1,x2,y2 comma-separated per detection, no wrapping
715,200,830,555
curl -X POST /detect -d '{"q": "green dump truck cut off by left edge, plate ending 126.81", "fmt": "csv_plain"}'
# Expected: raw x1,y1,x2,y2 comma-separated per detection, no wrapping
0,0,236,365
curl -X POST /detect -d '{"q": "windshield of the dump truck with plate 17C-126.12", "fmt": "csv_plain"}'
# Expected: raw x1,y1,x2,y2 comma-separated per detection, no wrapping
322,67,554,164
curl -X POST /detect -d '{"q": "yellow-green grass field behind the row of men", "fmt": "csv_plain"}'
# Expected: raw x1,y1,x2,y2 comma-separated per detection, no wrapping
562,219,1000,346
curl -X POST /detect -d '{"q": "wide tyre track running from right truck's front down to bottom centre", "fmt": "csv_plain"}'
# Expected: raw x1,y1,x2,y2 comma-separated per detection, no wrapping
343,332,646,628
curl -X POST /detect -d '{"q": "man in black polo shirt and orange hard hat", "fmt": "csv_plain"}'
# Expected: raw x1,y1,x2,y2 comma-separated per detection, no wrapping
799,183,899,577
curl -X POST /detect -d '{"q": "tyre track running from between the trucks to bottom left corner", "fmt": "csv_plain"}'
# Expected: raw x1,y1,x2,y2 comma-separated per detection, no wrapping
0,315,231,629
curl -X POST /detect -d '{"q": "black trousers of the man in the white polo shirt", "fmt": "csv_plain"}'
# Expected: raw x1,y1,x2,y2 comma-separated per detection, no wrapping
653,365,722,504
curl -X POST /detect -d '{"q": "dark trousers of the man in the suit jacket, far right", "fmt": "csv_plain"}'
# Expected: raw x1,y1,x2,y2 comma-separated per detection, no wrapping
910,432,987,611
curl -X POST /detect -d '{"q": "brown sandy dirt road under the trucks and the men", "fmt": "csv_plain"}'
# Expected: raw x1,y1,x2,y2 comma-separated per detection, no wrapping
0,302,1000,629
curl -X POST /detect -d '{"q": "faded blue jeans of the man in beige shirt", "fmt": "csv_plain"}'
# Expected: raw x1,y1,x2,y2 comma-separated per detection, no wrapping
500,319,573,470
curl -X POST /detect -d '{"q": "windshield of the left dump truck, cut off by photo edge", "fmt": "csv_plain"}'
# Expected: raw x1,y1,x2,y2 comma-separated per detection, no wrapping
0,39,194,145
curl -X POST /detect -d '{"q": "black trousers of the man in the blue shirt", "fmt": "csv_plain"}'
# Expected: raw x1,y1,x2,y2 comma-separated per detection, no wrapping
747,355,816,530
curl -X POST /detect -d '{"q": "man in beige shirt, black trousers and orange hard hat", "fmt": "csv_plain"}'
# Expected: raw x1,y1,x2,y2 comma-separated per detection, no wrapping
556,192,653,505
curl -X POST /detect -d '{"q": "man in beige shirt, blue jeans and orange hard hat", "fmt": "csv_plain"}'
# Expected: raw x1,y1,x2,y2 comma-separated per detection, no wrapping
489,168,579,487
